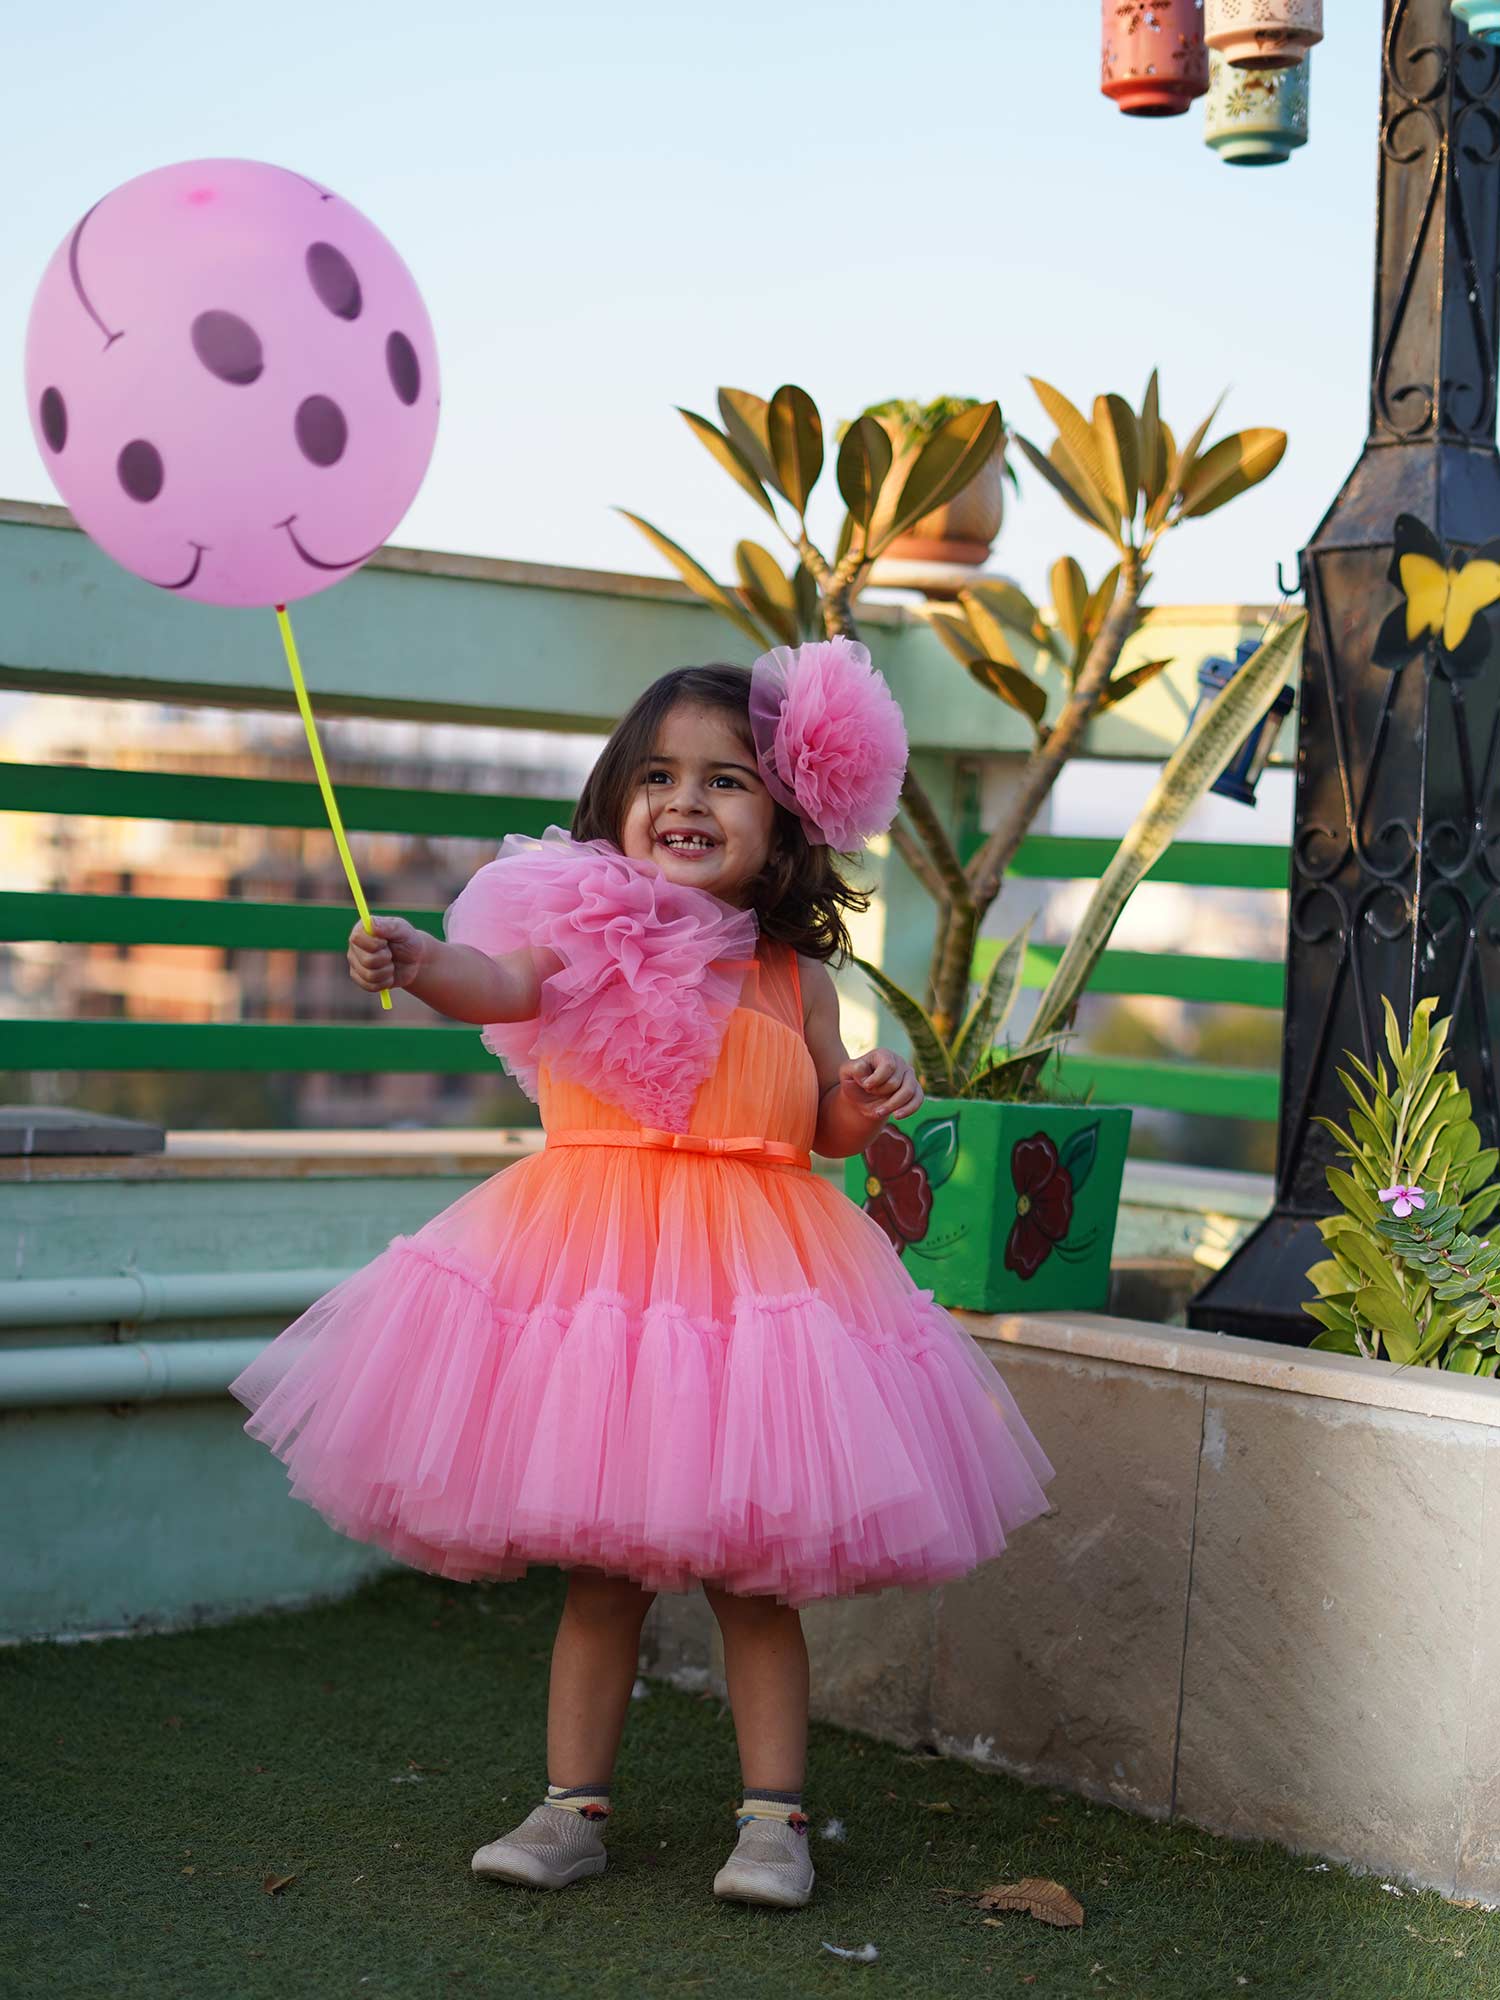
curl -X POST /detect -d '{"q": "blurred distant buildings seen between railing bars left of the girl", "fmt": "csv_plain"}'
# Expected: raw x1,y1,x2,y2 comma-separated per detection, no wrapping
0,696,598,1128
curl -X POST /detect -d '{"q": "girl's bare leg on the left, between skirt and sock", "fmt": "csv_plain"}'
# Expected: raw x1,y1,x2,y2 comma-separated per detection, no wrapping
546,1570,654,1786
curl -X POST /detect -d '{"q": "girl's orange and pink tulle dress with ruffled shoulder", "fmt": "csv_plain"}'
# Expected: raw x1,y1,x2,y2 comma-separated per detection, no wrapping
232,828,1052,1604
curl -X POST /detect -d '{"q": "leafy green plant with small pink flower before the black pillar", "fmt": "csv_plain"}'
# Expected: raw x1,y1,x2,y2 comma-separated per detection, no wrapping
1304,1000,1500,1376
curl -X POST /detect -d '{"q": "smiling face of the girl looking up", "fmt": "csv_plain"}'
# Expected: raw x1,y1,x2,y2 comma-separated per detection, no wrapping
620,702,776,904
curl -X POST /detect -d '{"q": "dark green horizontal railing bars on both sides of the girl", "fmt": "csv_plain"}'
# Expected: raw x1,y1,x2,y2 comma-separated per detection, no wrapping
0,762,1288,1120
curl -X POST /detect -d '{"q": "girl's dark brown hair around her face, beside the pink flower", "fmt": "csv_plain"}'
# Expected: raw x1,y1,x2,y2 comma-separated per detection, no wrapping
570,662,870,964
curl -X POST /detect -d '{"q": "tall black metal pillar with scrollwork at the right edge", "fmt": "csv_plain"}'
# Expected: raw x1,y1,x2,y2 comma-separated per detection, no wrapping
1188,0,1500,1344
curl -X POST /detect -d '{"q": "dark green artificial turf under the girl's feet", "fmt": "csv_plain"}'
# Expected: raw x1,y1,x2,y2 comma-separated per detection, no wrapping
0,1574,1500,2000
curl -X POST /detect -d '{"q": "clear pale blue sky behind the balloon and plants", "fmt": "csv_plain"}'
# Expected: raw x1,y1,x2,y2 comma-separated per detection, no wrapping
0,0,1380,602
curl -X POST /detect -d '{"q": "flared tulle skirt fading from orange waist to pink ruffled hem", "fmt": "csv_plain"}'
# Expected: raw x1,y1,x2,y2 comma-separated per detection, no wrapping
232,1148,1052,1604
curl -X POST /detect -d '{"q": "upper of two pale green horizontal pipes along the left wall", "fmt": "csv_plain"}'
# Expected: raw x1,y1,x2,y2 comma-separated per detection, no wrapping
0,1266,350,1326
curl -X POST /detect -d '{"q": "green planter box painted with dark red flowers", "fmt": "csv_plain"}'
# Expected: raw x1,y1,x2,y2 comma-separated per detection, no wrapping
844,1098,1130,1312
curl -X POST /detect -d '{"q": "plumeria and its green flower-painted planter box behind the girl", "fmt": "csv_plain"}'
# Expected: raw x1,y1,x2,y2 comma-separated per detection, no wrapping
626,374,1306,1310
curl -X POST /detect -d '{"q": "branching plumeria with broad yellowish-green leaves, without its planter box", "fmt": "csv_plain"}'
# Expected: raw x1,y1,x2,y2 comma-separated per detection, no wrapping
622,372,1286,1048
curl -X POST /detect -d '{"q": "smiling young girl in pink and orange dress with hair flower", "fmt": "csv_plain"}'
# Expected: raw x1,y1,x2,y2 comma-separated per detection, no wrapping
234,640,1052,1906
